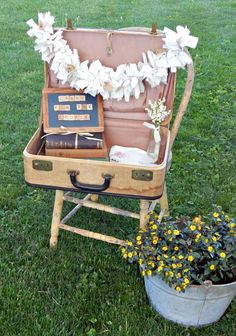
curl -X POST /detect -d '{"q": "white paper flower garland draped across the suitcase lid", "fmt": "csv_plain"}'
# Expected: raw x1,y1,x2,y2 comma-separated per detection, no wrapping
27,12,198,101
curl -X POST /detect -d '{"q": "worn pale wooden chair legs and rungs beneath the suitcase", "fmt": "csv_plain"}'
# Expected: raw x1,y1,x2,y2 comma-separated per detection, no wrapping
50,182,169,248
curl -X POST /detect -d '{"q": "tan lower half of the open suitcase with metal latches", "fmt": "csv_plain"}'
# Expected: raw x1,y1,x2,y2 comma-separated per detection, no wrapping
24,127,169,200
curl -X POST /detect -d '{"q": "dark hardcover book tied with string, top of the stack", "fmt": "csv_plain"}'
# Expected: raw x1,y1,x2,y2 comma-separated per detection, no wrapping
45,133,104,149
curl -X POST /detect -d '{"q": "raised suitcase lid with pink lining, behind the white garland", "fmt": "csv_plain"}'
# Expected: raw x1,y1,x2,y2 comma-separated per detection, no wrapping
45,28,176,125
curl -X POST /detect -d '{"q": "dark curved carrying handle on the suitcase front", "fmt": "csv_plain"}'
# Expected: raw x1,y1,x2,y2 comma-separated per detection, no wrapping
68,171,113,192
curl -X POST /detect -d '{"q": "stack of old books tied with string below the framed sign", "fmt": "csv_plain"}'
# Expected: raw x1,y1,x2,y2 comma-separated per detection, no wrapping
45,132,107,158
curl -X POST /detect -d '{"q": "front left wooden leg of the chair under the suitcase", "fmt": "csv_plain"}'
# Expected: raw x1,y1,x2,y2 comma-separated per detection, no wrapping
50,190,63,248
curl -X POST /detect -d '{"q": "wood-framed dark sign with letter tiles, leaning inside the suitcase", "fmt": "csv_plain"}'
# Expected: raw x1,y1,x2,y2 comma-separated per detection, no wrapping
43,88,104,133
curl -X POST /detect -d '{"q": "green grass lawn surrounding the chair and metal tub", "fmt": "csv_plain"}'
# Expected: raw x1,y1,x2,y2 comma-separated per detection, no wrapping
0,0,236,336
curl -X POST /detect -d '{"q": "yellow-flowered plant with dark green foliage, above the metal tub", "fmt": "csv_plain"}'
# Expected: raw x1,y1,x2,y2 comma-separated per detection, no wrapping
121,207,236,292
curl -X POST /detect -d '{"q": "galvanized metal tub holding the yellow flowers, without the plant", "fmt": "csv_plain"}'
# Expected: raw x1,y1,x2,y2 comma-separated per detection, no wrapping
144,276,236,326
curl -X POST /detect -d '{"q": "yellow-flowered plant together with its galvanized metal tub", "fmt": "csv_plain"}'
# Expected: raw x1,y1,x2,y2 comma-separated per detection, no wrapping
121,207,236,326
